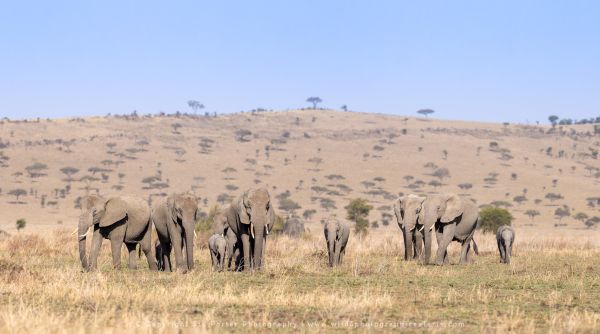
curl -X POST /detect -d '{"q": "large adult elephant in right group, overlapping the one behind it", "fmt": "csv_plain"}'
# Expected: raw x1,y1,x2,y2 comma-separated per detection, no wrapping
418,193,479,265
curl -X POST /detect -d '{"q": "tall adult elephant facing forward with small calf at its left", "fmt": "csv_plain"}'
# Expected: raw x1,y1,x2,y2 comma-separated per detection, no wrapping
226,188,275,271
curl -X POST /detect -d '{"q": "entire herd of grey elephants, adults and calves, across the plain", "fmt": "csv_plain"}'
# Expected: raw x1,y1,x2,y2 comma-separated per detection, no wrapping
78,188,515,273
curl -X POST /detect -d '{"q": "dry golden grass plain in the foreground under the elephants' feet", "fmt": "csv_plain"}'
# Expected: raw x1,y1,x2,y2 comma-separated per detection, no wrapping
0,230,600,333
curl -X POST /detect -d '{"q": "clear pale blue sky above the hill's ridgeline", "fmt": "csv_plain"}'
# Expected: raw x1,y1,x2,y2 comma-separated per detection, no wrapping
0,0,600,123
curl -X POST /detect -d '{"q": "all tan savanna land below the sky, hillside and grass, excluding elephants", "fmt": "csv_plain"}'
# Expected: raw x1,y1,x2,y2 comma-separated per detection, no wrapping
0,110,600,333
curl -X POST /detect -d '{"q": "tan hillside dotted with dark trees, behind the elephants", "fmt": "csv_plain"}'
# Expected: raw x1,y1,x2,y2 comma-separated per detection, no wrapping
0,110,600,240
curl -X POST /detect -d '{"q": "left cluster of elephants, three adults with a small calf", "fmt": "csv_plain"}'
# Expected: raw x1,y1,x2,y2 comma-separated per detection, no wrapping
78,188,275,273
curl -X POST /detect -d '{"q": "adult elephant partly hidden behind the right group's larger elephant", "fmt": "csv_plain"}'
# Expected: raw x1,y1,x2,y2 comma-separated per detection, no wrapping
394,194,431,261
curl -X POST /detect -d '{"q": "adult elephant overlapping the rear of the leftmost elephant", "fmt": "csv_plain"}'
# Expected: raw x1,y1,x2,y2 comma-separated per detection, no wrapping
152,194,198,274
